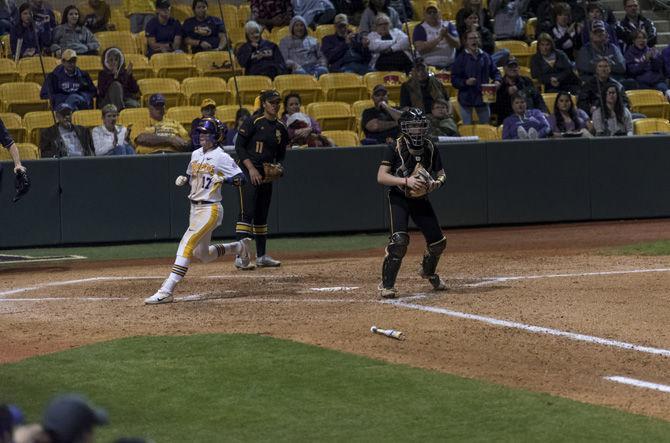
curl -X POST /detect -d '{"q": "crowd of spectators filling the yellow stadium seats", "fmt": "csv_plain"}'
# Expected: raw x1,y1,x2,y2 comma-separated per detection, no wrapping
0,0,670,157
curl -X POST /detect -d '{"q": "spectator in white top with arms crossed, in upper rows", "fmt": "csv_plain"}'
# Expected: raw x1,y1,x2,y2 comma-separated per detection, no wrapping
368,13,412,73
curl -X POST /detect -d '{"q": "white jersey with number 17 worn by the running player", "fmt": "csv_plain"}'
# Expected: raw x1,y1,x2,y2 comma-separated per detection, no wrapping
186,147,242,202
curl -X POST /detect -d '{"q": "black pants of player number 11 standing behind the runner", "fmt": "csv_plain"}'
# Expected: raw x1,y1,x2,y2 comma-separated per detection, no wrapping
235,179,272,257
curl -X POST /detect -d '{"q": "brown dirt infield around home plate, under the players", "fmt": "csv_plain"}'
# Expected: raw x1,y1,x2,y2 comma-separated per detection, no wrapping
0,220,670,420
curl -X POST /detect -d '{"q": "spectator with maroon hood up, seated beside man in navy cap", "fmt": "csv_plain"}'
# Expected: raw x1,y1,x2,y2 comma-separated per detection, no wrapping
98,48,140,110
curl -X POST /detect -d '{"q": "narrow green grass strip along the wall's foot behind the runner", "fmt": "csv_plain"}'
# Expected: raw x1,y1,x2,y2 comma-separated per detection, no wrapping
0,234,388,260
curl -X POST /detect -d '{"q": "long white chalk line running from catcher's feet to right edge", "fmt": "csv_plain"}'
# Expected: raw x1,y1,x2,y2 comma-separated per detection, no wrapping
381,300,670,357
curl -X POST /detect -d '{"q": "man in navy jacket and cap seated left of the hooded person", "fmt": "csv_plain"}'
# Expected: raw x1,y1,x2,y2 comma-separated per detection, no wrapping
40,49,96,111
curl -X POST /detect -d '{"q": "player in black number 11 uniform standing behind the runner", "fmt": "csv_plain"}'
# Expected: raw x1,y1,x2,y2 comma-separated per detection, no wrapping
235,90,289,269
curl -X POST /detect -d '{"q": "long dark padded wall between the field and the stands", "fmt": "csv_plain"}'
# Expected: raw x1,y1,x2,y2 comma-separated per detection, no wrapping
0,136,670,248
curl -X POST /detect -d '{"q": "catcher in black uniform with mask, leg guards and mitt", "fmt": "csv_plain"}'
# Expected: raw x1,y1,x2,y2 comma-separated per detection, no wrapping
377,108,447,298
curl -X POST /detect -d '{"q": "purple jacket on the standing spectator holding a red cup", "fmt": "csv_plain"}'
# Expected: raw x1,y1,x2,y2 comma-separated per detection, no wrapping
451,49,502,107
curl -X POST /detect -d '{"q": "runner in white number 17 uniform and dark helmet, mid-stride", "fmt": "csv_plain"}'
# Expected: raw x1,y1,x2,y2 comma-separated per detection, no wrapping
144,118,251,304
